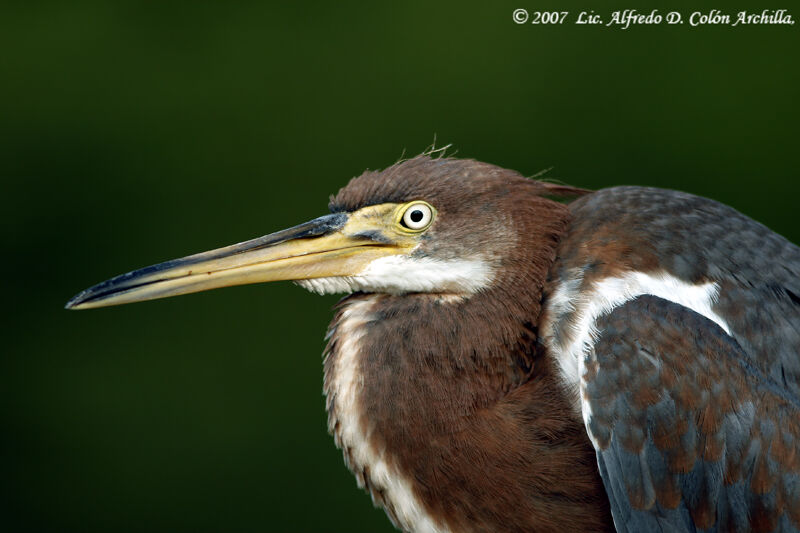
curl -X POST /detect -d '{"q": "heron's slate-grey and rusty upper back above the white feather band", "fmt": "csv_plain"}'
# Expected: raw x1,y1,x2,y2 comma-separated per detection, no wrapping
555,187,800,395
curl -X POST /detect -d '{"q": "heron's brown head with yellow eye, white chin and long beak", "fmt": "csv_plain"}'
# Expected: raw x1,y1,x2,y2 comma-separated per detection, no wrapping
67,156,580,309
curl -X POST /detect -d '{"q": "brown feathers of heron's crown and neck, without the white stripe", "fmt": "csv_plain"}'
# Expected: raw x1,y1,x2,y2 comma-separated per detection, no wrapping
325,157,612,531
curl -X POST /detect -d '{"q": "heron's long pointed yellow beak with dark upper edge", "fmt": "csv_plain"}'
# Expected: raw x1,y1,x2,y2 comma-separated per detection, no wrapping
66,206,407,309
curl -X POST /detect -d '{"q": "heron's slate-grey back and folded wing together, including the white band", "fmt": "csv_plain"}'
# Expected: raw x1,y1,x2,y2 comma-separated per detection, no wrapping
541,187,800,531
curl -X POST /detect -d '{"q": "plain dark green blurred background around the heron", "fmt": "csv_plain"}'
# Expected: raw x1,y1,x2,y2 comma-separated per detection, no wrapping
0,0,800,532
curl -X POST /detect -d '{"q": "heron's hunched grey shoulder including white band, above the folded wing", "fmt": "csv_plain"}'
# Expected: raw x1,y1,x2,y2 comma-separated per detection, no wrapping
543,186,800,394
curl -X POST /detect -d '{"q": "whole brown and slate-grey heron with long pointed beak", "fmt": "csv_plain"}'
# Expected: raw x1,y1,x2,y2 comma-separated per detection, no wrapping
67,154,800,532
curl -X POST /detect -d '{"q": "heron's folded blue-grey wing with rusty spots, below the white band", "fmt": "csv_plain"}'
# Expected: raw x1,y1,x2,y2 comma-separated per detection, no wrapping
581,296,800,531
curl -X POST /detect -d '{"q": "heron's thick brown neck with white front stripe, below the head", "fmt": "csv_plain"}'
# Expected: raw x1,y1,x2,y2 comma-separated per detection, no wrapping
325,200,610,531
